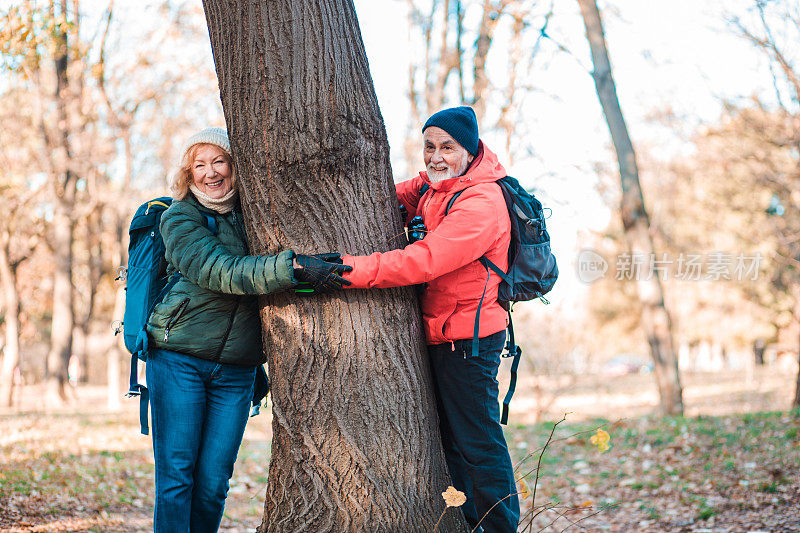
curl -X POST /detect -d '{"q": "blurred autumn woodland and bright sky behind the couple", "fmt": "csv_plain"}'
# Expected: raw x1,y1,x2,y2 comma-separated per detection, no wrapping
0,0,800,531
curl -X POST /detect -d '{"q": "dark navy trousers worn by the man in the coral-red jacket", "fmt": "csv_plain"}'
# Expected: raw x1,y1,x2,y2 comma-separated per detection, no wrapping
428,331,519,533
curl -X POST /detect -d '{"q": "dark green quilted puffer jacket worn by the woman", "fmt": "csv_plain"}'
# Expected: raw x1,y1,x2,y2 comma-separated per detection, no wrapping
147,194,296,366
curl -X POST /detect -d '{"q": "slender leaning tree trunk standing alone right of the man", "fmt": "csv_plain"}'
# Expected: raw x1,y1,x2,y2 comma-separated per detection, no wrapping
578,0,683,414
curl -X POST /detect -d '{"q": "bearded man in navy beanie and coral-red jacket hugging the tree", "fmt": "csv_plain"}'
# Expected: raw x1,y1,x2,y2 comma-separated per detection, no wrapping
343,106,519,533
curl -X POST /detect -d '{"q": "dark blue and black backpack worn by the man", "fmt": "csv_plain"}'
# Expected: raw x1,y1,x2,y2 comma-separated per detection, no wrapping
420,176,558,424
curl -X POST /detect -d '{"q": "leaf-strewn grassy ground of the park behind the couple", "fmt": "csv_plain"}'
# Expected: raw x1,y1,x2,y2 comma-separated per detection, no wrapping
0,368,800,533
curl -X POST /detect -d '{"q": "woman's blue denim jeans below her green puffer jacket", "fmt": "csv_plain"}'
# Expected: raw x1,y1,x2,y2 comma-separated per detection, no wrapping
147,350,255,533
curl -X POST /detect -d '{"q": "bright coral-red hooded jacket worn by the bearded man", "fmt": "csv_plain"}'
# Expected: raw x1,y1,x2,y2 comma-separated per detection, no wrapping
343,142,511,344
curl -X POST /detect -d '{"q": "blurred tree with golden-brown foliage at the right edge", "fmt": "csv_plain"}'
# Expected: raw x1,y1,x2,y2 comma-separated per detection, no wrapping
664,108,800,400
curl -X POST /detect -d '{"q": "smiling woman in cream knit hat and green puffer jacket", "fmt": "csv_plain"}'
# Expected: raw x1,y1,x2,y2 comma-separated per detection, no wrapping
147,128,349,533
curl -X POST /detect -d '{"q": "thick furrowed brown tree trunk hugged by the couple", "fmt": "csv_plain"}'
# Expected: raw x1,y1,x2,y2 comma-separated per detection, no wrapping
204,0,465,533
